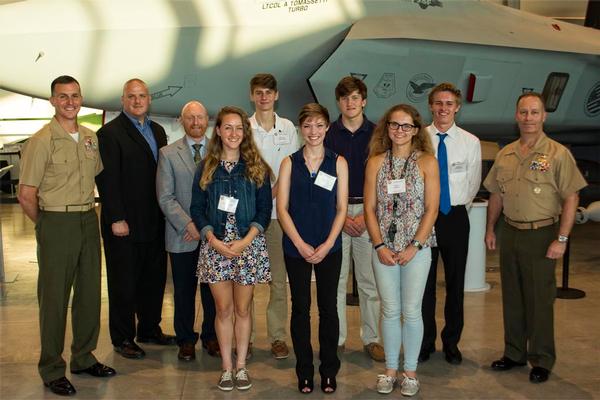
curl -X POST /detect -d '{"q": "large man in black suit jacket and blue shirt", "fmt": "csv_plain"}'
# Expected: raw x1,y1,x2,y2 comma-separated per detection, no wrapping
96,79,175,358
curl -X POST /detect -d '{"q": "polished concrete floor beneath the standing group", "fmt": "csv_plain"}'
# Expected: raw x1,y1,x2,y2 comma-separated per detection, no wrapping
0,204,600,400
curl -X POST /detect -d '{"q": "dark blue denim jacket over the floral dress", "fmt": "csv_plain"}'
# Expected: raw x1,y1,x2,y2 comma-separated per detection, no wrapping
190,160,273,239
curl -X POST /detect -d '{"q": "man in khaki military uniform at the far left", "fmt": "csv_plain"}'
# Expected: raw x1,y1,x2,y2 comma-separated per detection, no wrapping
19,76,115,396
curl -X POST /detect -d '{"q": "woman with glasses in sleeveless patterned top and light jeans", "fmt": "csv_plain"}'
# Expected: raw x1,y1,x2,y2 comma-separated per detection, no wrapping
365,104,440,396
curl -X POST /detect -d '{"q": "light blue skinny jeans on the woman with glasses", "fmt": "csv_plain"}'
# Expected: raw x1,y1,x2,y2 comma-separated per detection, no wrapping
373,247,431,371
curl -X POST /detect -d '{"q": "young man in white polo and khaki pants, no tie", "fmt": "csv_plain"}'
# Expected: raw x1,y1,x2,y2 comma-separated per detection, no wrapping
250,74,300,359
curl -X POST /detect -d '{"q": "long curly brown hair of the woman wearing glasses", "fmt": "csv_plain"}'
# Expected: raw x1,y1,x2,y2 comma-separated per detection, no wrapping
369,104,434,158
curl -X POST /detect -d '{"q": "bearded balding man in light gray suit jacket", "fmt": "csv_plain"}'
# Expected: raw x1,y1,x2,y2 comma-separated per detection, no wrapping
156,101,220,361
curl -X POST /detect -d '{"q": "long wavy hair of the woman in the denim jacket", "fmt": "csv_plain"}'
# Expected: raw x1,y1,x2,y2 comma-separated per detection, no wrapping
200,106,273,190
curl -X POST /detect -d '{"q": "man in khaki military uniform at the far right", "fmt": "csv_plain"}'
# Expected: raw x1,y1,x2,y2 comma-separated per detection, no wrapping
484,93,586,383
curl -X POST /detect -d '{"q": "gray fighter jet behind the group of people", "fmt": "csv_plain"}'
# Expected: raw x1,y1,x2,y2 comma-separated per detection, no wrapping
0,0,600,144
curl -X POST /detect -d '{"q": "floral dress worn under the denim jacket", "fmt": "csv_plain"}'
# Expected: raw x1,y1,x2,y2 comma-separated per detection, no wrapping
197,214,271,285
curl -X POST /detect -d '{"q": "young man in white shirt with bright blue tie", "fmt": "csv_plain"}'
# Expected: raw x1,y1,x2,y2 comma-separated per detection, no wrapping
419,83,481,364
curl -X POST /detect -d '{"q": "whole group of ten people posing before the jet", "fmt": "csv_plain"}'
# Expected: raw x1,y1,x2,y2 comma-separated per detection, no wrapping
19,74,585,396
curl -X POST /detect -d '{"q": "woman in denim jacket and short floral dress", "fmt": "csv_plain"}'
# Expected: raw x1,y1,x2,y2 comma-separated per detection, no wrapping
190,106,273,391
